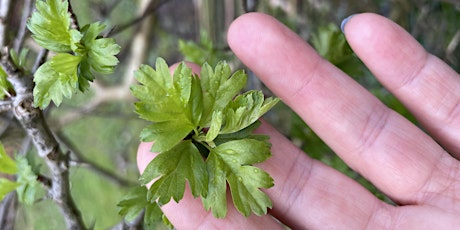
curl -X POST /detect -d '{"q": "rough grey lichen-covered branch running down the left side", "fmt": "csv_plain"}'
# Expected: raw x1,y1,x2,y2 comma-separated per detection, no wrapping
0,49,84,229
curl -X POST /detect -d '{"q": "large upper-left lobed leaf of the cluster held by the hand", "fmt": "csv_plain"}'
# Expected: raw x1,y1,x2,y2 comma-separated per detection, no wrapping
131,59,201,152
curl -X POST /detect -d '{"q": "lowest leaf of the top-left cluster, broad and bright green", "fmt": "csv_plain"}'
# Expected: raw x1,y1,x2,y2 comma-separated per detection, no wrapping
34,53,81,108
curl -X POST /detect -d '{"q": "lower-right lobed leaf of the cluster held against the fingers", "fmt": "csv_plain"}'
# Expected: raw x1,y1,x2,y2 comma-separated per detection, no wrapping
202,139,273,218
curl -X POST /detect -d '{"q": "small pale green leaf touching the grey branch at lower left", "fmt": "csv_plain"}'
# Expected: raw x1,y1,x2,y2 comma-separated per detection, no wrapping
16,156,40,204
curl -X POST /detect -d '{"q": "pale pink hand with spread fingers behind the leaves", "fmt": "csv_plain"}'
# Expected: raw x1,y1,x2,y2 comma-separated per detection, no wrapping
138,13,460,229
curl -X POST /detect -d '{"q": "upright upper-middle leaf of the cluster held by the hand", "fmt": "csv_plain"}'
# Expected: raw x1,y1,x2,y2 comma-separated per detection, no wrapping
200,62,247,127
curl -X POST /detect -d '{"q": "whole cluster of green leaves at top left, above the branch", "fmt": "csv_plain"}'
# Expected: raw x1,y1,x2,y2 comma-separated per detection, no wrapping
27,0,120,108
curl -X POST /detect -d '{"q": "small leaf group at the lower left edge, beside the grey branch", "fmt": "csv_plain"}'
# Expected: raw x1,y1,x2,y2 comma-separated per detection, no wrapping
0,143,39,204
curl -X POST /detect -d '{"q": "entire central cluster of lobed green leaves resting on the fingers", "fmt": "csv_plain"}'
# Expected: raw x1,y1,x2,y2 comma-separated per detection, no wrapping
131,58,279,218
